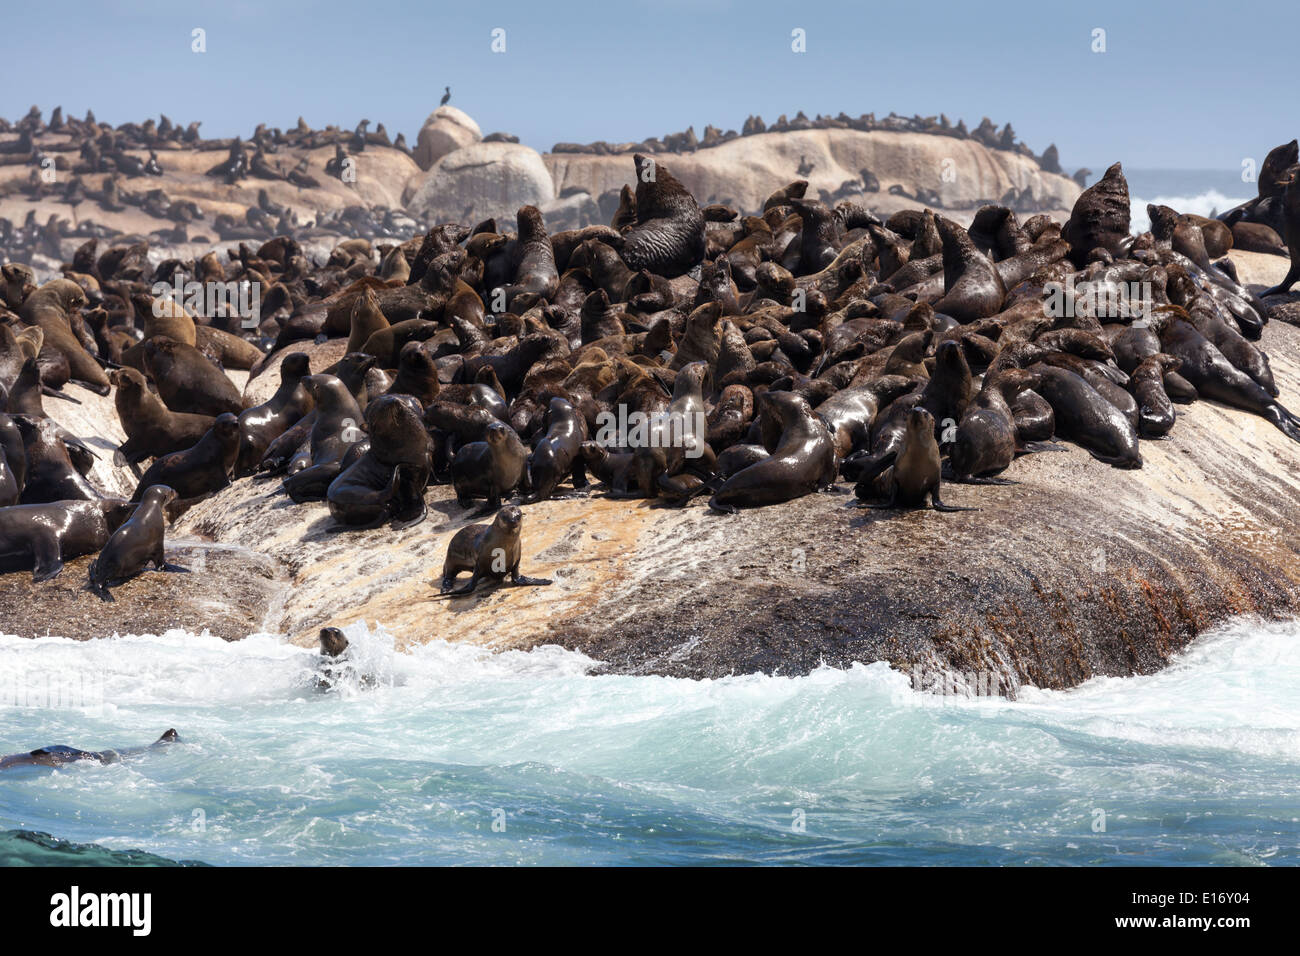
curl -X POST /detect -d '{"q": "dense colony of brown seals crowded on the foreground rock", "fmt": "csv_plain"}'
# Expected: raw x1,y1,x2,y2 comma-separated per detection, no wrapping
0,140,1300,658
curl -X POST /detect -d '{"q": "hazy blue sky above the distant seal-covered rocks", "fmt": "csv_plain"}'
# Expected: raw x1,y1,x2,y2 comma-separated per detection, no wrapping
0,0,1300,173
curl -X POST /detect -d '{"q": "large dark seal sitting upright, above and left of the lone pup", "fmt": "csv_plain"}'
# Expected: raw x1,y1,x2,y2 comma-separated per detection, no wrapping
325,395,433,528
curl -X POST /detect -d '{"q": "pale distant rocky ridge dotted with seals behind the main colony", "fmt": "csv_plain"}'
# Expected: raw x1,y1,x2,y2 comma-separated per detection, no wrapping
0,105,1079,272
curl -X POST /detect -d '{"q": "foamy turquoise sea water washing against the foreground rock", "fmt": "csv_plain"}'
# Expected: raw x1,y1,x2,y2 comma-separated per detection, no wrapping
0,622,1300,865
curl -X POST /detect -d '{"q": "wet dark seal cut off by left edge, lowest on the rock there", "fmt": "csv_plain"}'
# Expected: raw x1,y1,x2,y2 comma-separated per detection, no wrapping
0,498,135,583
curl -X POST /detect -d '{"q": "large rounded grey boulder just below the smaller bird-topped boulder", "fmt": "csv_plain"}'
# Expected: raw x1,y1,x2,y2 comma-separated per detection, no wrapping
407,143,556,222
